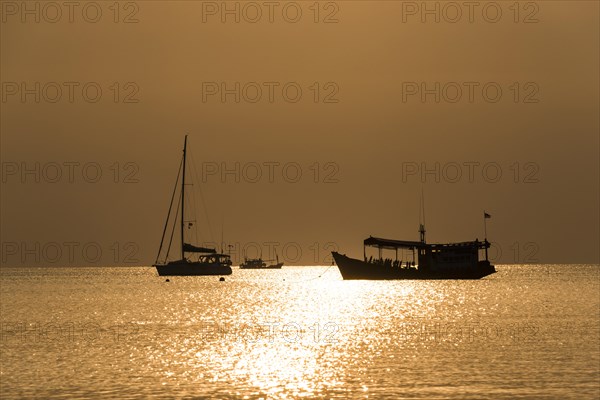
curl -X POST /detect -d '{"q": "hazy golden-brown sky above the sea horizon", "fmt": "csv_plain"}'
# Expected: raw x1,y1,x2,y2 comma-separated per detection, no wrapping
0,1,600,265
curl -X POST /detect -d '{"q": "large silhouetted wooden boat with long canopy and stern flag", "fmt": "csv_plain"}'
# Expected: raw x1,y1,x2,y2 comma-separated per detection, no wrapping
331,211,496,280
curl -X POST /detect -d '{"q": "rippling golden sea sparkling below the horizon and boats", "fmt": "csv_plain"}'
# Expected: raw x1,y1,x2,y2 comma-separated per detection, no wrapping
0,265,600,399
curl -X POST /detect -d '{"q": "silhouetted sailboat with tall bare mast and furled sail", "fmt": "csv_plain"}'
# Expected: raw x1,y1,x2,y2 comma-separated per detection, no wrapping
154,135,232,276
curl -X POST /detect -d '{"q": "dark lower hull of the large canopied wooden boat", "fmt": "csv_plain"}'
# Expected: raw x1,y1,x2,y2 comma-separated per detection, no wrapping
331,251,496,280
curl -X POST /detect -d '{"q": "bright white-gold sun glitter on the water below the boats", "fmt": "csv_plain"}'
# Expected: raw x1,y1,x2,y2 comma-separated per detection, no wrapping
143,280,444,398
